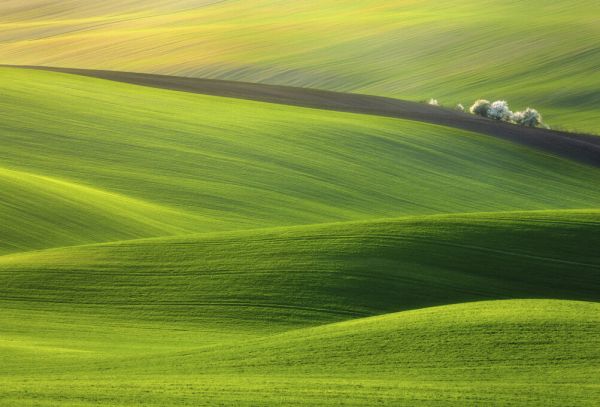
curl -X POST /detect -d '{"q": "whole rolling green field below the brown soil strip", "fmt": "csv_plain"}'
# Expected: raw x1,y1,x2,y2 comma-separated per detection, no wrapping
0,67,600,407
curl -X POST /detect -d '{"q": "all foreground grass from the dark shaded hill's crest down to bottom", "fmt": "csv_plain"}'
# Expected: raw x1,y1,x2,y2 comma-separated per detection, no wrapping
0,211,600,405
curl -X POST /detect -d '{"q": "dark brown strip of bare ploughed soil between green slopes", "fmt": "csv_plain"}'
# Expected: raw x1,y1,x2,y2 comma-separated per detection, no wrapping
0,65,600,167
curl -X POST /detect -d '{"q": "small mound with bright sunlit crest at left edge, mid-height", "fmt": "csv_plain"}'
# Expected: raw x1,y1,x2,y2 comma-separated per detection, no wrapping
0,168,201,253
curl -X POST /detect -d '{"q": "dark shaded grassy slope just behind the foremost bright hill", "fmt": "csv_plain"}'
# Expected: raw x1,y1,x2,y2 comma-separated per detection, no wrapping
0,211,600,331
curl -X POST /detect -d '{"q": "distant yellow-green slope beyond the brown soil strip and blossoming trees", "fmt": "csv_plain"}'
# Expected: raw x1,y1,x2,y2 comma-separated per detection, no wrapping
0,0,600,132
